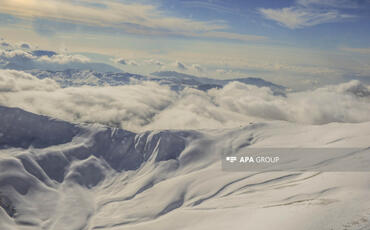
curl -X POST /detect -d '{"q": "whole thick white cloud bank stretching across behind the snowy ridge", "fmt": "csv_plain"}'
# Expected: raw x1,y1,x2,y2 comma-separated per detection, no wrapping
0,70,370,131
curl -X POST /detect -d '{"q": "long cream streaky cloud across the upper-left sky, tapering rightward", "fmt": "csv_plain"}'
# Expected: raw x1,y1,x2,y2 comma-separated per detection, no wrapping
0,0,265,40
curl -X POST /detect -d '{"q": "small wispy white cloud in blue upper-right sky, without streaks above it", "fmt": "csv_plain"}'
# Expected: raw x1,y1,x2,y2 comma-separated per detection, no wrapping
259,7,353,29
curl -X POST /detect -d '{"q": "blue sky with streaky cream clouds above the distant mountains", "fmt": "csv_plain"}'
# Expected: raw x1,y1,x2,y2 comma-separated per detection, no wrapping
0,0,370,88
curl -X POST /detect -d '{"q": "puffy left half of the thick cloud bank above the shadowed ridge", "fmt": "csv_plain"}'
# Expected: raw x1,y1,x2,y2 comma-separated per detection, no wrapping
0,70,176,130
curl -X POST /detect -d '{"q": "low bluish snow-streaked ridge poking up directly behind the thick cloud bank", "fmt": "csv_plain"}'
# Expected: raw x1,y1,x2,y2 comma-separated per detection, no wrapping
28,69,285,94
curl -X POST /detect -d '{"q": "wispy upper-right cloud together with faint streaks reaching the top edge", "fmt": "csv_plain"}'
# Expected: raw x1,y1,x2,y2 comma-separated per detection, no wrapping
258,0,355,29
